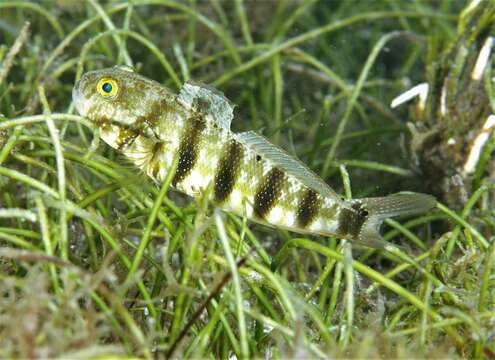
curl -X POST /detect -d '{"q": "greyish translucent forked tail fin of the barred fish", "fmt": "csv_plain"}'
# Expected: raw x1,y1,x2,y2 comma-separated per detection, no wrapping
356,193,436,248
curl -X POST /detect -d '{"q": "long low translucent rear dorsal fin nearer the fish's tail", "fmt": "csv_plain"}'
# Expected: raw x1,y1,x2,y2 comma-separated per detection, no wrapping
236,131,340,202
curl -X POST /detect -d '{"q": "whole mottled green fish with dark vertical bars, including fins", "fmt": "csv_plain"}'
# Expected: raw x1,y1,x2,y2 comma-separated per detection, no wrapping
73,67,435,247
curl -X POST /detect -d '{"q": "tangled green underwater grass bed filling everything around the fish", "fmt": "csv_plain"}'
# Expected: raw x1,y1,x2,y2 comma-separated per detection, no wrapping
0,0,495,359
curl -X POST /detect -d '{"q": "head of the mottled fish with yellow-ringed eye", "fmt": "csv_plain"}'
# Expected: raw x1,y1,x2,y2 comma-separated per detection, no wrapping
72,66,174,129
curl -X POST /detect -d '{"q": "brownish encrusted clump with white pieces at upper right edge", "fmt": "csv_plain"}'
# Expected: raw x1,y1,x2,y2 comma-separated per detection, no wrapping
410,2,495,209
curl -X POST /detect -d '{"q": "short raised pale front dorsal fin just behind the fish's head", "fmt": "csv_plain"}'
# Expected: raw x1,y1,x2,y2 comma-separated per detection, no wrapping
179,81,234,129
